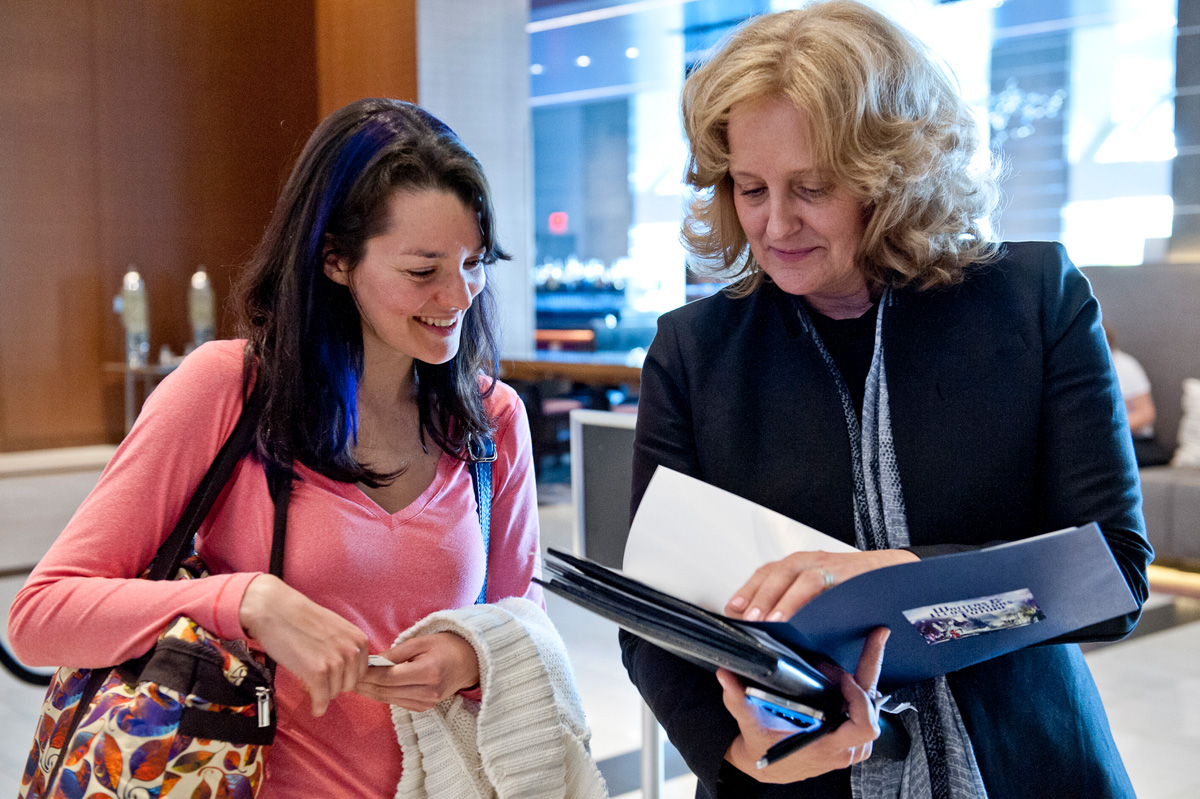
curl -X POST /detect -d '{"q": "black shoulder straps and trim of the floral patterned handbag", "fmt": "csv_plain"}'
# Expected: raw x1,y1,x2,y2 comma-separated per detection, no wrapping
46,385,284,786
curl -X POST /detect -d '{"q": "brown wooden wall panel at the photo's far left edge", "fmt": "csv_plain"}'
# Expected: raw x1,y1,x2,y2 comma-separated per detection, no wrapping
0,0,104,449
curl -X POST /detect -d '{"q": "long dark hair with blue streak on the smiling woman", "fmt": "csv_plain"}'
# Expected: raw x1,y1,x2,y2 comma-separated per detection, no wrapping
238,98,509,486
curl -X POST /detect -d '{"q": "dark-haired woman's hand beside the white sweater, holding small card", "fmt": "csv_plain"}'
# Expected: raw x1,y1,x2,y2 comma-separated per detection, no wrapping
354,632,479,713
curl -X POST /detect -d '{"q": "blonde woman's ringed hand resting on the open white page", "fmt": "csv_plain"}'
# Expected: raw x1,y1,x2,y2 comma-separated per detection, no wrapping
725,549,918,621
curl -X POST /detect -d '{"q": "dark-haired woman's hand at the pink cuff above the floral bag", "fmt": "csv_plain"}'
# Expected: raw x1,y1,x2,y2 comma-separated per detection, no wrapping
239,575,367,716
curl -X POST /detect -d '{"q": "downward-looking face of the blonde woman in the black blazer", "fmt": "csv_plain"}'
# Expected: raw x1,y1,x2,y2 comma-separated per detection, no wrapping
728,98,871,318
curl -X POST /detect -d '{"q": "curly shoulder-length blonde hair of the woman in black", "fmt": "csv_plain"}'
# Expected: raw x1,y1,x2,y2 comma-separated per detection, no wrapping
682,0,1000,294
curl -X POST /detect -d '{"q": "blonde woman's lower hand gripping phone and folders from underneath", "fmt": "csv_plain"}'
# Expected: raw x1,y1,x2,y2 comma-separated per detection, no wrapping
716,627,890,782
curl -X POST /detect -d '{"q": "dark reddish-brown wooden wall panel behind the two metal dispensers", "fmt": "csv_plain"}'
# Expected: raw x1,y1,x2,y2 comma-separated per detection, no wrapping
89,0,317,369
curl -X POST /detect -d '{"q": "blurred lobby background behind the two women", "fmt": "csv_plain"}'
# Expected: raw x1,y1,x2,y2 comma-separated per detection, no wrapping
0,0,1200,799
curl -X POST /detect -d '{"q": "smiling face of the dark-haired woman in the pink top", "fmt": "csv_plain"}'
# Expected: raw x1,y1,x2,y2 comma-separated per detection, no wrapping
325,190,486,374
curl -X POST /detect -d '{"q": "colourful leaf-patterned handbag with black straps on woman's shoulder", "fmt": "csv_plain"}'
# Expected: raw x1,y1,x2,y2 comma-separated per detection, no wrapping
19,383,292,799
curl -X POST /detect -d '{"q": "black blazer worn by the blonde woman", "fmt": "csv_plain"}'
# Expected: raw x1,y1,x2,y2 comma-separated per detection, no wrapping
622,242,1152,798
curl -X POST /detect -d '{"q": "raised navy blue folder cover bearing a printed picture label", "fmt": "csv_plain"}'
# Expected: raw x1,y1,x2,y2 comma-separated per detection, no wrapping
751,522,1138,692
